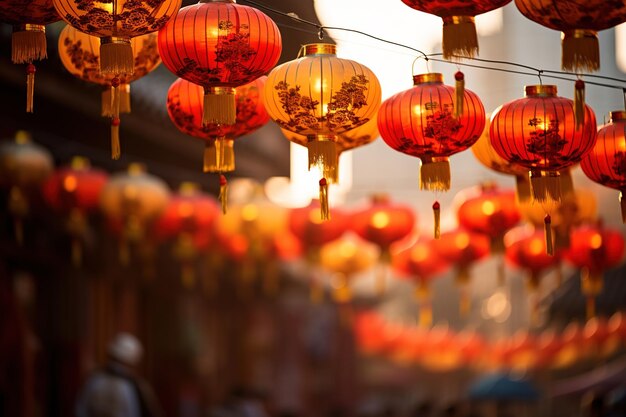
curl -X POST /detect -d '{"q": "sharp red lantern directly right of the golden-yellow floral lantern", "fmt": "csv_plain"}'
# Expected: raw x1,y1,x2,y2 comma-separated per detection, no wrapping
378,73,485,238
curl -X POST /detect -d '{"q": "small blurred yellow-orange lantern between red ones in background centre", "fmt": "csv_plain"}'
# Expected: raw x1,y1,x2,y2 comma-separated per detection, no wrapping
320,235,378,304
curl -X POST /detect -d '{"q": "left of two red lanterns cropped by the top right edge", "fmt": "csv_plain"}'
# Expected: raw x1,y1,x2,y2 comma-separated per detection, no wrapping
402,0,511,59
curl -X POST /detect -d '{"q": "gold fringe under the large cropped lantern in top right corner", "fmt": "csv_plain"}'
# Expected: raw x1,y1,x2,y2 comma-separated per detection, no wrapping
561,29,600,72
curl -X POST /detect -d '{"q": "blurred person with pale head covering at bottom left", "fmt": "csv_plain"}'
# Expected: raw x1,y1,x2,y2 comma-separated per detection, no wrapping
76,333,161,417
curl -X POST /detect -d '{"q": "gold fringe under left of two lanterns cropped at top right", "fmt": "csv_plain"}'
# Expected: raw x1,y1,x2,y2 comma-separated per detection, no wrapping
441,16,478,60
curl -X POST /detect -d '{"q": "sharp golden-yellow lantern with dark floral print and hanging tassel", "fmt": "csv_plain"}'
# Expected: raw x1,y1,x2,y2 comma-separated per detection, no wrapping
265,43,381,220
